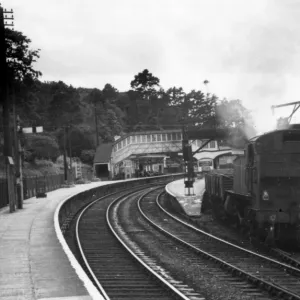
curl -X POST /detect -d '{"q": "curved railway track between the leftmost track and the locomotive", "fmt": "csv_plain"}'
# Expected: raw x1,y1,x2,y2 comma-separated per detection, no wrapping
139,191,300,299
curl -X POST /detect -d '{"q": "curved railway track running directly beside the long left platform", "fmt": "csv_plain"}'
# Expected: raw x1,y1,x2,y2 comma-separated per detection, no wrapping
76,187,196,300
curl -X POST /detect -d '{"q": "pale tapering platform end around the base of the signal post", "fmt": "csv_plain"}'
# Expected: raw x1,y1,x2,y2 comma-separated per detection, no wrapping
166,178,205,216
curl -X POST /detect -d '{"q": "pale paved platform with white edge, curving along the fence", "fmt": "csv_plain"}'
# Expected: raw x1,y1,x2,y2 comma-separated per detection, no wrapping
0,181,111,300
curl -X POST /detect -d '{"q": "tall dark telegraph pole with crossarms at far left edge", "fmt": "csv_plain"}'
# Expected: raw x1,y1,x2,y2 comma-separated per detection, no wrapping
0,6,15,212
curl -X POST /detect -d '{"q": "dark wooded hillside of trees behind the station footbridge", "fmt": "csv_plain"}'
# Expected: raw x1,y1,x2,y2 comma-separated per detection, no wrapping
0,29,254,171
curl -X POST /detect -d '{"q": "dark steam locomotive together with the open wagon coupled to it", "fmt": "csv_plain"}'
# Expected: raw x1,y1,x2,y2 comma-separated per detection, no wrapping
204,126,300,244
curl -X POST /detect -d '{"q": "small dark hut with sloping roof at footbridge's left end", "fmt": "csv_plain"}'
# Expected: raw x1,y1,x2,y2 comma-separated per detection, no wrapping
93,143,114,180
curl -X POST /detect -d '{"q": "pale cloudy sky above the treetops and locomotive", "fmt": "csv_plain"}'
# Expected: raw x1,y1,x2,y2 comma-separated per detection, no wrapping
2,0,300,133
